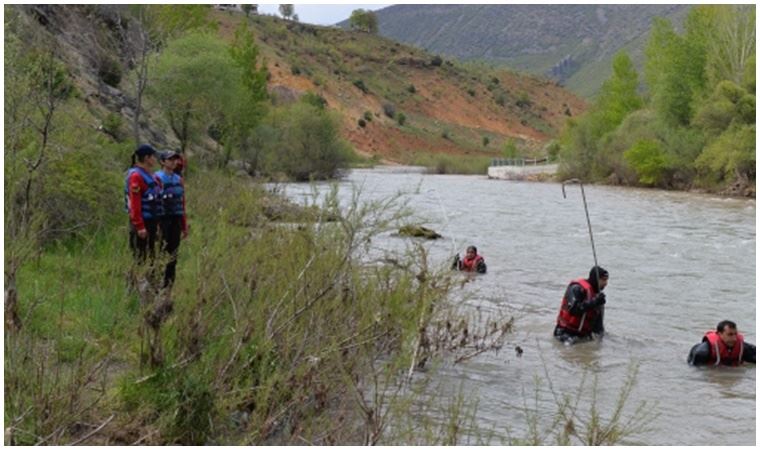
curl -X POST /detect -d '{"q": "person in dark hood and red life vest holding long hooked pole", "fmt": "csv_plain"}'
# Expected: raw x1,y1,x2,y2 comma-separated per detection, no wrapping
554,266,610,345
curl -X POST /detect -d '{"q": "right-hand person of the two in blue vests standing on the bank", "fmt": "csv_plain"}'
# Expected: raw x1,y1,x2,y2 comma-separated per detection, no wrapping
156,150,187,287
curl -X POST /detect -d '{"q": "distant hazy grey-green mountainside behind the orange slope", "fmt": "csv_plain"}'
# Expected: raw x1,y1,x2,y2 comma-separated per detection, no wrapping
368,5,689,97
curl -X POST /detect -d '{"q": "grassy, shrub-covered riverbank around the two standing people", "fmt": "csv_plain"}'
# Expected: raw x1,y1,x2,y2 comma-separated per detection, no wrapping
5,172,476,445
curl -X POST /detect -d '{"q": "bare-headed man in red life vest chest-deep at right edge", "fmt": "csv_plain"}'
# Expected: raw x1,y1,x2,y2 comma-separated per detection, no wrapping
687,320,756,367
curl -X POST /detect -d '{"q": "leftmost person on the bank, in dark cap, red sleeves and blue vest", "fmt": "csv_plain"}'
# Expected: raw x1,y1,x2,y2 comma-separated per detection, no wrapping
124,144,163,263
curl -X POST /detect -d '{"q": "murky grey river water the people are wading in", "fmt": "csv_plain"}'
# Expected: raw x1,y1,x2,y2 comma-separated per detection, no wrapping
278,167,756,445
